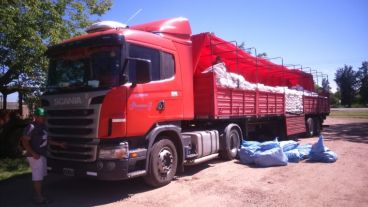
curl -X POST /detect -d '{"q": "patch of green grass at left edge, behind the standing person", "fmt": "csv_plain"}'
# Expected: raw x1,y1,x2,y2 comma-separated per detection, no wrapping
0,157,31,181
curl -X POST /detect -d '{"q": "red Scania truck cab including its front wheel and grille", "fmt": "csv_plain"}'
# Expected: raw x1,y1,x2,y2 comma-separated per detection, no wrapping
42,18,201,186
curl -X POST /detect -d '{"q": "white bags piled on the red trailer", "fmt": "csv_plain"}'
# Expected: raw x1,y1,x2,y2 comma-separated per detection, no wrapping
202,63,318,113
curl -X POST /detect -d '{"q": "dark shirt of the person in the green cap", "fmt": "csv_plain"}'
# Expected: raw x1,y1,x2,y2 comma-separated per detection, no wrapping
24,122,47,156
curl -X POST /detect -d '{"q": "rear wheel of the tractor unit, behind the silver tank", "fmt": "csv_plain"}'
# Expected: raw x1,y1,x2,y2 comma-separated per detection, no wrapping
220,127,240,160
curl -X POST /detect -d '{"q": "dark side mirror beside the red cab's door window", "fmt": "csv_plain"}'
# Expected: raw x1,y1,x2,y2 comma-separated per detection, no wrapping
127,58,152,86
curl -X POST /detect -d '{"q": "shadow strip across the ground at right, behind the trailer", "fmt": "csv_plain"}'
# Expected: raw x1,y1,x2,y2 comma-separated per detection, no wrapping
322,123,368,144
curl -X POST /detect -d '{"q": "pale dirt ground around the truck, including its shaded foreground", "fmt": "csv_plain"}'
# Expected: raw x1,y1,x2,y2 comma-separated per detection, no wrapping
0,118,368,207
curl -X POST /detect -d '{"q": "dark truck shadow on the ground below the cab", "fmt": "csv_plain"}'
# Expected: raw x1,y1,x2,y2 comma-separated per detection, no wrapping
0,159,221,207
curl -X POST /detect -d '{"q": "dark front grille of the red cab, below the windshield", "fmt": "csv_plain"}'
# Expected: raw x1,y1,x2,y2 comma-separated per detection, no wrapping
47,107,99,162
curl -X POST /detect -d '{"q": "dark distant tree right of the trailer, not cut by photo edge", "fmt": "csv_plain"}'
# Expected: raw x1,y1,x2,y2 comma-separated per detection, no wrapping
335,65,357,107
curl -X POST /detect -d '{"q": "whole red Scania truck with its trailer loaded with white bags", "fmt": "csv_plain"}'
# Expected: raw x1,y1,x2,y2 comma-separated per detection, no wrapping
42,18,329,187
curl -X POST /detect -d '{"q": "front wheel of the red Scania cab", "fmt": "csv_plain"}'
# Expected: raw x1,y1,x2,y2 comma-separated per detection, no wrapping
144,137,178,187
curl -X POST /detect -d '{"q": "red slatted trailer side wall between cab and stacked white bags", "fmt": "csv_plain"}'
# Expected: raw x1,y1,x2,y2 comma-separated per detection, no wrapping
194,73,285,118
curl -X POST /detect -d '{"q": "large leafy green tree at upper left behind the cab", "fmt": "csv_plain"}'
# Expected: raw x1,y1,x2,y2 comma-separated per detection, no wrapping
0,0,112,109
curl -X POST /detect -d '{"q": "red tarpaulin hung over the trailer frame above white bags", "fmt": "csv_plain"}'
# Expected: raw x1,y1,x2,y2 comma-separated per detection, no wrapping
191,33,315,91
